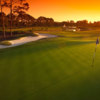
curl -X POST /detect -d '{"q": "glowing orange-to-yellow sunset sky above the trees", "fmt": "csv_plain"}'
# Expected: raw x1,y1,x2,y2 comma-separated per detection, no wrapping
25,0,100,21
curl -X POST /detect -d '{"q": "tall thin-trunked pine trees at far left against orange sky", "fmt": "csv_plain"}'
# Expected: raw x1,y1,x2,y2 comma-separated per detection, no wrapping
0,0,29,38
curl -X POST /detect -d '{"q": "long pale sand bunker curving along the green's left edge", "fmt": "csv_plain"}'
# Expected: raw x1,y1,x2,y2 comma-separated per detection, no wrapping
0,34,57,49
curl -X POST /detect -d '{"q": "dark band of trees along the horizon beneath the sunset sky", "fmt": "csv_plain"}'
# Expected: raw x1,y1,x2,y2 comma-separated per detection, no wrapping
0,11,100,28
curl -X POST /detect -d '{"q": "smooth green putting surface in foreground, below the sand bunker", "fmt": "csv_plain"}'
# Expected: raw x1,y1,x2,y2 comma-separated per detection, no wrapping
0,30,100,100
